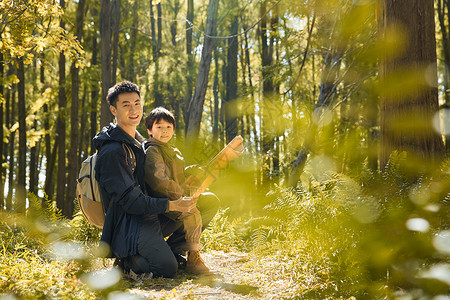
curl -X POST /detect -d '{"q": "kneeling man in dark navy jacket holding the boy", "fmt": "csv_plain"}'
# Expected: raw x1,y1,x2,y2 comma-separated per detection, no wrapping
93,81,218,277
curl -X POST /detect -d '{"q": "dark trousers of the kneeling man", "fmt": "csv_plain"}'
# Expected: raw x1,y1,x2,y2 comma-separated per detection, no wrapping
124,193,219,277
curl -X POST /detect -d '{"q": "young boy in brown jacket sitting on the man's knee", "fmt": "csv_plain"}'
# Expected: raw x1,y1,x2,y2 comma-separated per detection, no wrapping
144,107,209,274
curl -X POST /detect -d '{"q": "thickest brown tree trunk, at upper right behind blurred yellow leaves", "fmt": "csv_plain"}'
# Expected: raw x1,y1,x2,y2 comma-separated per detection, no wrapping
380,0,444,168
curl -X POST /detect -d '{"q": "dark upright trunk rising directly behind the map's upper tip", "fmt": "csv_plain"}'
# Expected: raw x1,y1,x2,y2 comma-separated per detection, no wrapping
224,12,239,143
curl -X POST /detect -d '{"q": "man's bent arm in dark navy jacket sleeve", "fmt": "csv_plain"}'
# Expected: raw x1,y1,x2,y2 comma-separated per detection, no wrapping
96,143,168,215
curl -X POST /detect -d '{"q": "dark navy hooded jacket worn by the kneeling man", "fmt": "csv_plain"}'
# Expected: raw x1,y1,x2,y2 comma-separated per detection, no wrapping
93,123,168,258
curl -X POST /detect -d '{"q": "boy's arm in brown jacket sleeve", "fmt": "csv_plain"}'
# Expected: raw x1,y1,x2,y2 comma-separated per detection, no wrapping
145,147,184,200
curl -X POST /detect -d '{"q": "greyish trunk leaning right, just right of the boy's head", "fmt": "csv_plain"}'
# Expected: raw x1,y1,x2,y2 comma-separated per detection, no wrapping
186,0,219,146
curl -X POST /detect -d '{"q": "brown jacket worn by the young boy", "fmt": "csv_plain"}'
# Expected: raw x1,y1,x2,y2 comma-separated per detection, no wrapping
144,138,185,200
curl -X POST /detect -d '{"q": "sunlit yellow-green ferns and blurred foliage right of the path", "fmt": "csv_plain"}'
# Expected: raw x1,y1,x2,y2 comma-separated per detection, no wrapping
204,153,450,299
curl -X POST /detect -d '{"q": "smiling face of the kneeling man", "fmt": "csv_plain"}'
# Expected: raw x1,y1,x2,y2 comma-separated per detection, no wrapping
109,92,142,130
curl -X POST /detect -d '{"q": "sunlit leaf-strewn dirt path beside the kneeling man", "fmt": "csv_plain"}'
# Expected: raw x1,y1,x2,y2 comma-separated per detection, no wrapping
110,251,306,299
